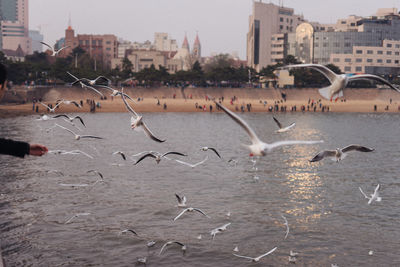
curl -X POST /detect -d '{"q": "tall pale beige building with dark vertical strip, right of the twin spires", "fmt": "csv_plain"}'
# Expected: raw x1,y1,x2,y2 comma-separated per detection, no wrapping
247,1,304,71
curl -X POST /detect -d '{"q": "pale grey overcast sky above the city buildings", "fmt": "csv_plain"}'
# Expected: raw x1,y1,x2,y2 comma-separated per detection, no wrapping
29,0,400,59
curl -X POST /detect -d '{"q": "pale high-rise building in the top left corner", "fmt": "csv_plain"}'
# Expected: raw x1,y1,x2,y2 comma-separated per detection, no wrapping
0,0,32,54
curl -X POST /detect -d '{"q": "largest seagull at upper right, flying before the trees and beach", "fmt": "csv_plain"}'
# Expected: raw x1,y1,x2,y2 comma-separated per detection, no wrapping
283,64,400,101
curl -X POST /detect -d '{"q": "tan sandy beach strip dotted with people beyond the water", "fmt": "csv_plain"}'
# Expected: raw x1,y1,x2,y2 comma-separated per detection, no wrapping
0,88,400,117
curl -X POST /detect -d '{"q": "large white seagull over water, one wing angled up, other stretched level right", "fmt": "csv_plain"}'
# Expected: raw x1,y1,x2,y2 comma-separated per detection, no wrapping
213,99,323,157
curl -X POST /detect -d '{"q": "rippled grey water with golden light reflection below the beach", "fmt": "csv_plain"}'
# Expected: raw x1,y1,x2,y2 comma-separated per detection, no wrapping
0,113,400,266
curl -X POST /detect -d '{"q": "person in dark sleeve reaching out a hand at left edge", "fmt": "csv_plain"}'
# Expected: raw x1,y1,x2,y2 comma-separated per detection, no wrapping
0,63,49,158
